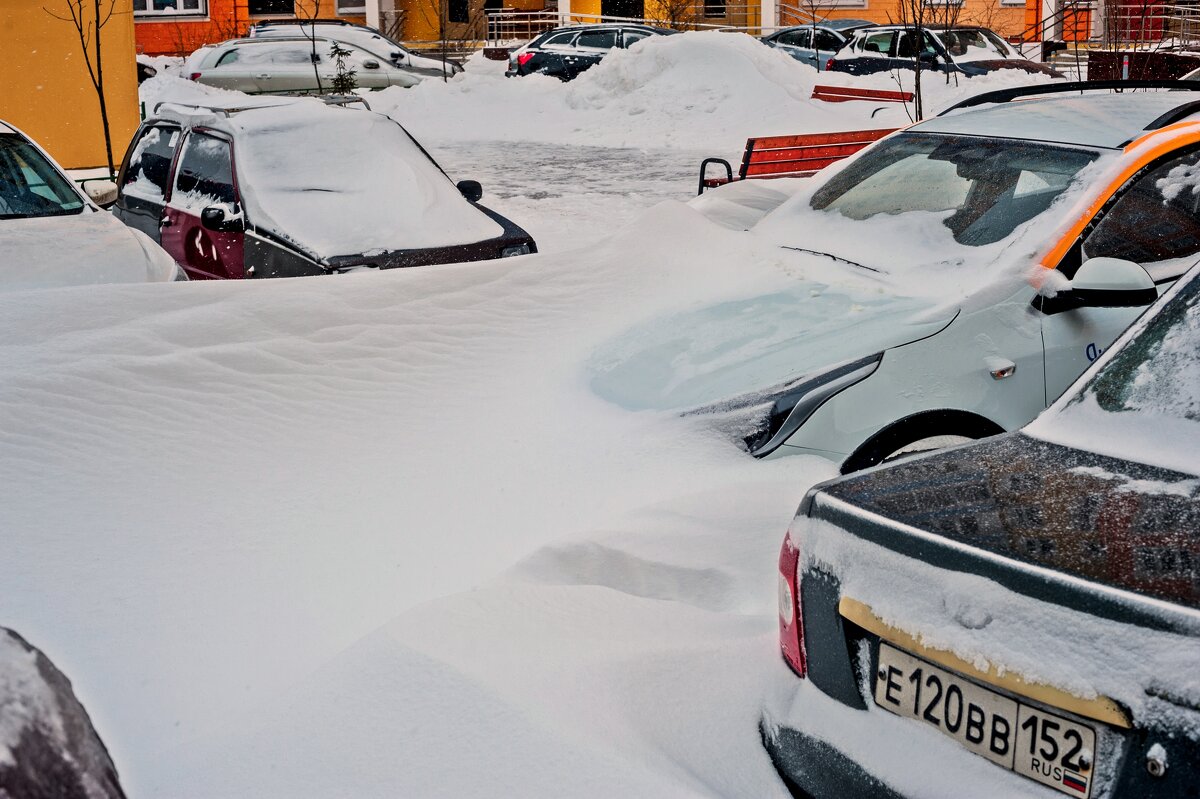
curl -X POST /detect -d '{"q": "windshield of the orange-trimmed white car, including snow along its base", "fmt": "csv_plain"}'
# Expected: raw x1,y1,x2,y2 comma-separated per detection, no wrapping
755,132,1111,296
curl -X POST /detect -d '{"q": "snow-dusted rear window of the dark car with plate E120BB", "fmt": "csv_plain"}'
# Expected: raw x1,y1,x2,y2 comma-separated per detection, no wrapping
1027,270,1200,474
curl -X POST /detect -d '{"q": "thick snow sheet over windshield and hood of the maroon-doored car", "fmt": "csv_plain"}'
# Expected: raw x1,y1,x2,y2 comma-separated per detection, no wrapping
235,102,503,257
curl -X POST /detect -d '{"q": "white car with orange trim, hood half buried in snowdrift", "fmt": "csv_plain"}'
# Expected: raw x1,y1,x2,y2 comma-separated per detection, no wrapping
592,83,1200,471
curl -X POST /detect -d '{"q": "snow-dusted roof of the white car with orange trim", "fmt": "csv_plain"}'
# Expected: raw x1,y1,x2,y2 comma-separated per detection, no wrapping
910,92,1194,149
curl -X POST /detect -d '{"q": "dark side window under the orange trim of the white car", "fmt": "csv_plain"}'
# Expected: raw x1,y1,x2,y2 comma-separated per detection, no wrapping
1084,150,1200,280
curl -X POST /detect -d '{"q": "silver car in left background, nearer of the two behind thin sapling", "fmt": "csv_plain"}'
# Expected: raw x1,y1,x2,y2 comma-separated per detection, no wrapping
187,36,421,95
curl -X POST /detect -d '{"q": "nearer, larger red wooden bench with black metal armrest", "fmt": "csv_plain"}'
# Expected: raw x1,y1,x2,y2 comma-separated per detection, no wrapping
696,128,895,194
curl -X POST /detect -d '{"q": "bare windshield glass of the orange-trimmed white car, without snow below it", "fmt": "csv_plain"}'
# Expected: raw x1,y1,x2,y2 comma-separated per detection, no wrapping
811,133,1099,246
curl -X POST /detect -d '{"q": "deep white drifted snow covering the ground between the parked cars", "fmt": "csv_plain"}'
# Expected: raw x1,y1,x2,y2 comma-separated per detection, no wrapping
0,34,1089,798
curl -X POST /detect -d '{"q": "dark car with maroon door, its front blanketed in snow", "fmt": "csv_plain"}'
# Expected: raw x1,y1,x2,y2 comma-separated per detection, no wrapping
114,97,536,278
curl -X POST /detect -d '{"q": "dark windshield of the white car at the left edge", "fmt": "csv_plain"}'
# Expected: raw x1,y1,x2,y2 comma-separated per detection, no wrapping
0,133,84,220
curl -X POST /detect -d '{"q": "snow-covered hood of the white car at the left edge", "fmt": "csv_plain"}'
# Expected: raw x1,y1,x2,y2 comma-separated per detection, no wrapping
0,211,176,292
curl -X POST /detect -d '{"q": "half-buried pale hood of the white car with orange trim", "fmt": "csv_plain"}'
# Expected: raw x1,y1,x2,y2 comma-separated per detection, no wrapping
589,281,955,410
